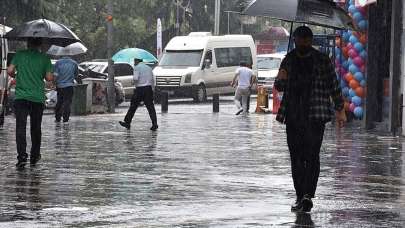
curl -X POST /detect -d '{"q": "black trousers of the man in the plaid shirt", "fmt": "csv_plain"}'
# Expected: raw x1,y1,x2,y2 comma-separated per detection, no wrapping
287,122,325,199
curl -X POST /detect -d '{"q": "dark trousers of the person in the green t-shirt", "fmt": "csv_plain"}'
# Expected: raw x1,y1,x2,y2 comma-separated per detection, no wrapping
14,100,44,161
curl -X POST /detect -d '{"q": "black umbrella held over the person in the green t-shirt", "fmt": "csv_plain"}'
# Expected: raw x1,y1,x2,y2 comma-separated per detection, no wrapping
5,19,81,47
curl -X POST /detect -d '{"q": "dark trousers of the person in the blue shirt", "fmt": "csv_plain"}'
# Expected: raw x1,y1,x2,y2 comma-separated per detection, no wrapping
55,86,73,121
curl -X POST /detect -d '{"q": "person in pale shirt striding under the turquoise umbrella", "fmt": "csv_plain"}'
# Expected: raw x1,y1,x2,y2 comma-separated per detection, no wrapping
119,59,158,131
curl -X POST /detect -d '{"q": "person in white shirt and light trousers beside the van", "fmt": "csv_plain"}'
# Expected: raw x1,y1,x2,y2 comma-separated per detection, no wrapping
231,62,254,115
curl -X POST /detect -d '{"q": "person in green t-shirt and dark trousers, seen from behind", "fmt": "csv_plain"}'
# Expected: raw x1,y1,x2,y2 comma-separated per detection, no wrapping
7,38,53,168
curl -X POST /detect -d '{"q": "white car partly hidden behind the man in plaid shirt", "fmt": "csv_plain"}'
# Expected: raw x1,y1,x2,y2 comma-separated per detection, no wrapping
257,52,286,91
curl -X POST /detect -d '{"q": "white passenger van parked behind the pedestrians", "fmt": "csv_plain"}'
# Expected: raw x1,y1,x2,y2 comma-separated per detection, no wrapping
153,32,257,102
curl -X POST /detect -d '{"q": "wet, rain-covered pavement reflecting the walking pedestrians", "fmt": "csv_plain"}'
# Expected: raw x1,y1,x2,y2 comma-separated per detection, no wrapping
0,98,405,227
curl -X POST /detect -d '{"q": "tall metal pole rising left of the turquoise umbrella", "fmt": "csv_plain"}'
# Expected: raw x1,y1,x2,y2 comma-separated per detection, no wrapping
107,0,115,113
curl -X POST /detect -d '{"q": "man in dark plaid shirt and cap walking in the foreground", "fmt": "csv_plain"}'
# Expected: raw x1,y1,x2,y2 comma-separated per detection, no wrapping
274,26,346,212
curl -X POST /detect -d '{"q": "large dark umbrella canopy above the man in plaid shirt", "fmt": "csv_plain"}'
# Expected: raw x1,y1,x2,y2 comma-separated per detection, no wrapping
244,0,355,30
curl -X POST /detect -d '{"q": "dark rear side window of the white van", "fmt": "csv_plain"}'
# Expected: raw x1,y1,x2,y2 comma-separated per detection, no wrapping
214,47,253,67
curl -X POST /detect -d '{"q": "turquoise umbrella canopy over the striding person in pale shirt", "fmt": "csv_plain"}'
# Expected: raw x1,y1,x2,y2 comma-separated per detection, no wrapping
112,48,158,64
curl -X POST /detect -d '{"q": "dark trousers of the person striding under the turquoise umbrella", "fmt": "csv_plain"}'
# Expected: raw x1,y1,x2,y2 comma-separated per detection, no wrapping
124,86,157,126
